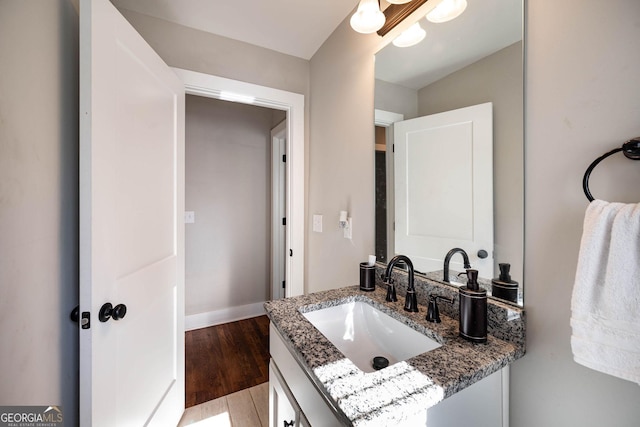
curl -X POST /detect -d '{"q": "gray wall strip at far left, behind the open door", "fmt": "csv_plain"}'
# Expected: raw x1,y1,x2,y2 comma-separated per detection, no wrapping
0,0,78,425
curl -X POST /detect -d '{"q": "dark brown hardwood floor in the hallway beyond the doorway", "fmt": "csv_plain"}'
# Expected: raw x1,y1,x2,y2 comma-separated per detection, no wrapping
185,316,269,408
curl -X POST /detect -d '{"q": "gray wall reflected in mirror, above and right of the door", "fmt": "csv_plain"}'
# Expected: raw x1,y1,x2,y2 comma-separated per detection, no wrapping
418,42,524,282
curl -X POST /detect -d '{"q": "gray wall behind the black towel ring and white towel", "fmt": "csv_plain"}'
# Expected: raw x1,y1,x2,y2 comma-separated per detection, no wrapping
511,0,640,427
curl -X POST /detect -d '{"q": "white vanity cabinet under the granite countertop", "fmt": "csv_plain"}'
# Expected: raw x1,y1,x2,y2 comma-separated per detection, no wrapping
269,325,509,427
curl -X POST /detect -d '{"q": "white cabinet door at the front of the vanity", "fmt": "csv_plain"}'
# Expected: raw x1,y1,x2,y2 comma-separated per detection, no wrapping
269,360,300,427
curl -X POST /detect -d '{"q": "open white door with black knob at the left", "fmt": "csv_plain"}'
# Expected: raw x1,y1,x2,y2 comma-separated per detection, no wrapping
80,0,184,427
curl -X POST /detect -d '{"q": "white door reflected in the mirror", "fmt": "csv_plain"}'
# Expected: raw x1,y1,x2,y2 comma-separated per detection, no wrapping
394,103,493,278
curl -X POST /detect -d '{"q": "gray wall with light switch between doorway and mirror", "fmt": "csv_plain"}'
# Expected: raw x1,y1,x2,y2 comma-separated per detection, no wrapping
305,17,379,292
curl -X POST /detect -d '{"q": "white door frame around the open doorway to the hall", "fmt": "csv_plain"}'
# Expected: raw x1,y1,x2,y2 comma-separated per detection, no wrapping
172,67,305,297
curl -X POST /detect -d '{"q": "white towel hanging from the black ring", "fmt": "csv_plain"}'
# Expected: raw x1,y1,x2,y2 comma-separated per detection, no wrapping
571,200,640,384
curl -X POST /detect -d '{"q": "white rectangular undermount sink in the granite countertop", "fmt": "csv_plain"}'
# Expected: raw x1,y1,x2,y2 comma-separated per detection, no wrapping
303,301,441,372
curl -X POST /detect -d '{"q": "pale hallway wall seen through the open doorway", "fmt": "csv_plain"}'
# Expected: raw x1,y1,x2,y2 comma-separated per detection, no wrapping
185,95,282,316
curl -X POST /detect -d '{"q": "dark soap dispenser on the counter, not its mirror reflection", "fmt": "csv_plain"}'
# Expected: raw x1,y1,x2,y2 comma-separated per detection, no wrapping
458,269,487,343
